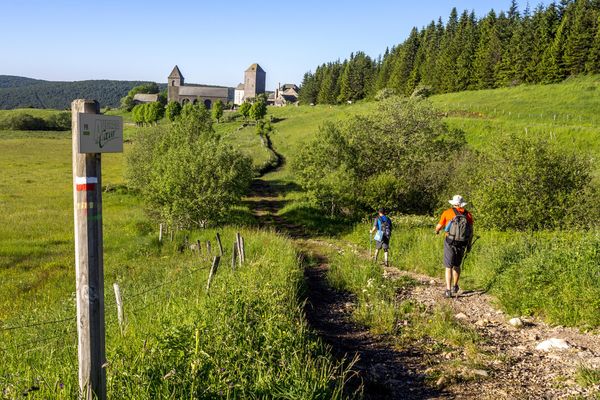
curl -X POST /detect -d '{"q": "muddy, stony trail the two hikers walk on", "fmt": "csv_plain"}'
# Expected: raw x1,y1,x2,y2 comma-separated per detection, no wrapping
247,174,600,399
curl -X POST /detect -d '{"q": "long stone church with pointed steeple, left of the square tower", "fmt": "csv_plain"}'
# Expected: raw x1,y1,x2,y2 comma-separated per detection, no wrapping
167,65,233,109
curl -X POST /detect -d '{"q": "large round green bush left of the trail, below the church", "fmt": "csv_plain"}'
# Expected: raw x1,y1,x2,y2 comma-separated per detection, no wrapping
127,104,253,228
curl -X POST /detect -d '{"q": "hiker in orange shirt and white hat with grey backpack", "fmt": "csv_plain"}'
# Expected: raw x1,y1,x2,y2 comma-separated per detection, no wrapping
435,194,473,297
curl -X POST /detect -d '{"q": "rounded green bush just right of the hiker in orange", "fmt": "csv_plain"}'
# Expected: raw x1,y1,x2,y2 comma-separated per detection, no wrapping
470,137,600,230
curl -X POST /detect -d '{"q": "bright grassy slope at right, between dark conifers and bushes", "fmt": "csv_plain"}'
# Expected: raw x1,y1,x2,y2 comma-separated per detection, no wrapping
431,75,600,172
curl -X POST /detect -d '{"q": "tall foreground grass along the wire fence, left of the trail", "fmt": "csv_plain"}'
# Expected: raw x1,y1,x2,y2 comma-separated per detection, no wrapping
0,228,346,399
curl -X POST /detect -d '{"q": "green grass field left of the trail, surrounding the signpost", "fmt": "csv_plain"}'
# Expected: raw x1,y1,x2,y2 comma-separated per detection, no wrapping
0,133,346,399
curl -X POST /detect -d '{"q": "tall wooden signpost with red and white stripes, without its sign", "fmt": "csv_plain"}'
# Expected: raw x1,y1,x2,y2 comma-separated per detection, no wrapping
71,99,106,400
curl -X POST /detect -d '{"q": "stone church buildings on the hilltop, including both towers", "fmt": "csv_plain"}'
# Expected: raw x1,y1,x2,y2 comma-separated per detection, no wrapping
167,63,266,109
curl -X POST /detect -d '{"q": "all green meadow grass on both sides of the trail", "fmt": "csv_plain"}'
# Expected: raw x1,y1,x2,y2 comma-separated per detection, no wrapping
0,76,600,399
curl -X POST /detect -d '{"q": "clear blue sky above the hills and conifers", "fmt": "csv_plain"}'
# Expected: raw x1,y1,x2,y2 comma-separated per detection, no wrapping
0,0,547,89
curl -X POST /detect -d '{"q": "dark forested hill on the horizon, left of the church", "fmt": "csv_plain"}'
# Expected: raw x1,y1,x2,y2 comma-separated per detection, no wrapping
0,75,166,110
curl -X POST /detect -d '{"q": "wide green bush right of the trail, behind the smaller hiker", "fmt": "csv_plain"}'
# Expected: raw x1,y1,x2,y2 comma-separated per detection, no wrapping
294,97,465,213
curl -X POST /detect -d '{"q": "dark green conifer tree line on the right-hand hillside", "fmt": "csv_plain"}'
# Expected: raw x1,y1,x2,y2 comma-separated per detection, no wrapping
299,0,600,104
